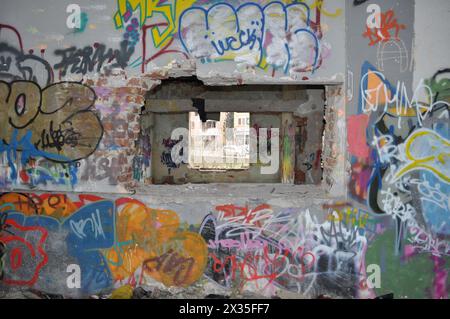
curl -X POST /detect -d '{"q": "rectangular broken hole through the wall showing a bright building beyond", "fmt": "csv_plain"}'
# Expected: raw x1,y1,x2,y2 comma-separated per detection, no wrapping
142,79,330,185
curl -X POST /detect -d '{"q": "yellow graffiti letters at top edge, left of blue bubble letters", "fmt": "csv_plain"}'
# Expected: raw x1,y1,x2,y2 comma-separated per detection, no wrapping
114,0,196,48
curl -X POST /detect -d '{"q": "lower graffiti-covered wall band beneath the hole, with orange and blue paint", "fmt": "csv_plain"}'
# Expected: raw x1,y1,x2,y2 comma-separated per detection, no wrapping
0,193,377,298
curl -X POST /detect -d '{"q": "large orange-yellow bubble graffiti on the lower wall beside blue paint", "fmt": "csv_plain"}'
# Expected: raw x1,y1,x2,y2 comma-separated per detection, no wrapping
105,202,208,287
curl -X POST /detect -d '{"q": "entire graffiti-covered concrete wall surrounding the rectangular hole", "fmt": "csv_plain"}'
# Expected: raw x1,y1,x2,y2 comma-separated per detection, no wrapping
0,0,449,298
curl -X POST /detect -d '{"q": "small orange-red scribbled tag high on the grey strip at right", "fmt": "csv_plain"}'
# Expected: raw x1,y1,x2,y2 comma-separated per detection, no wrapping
363,9,406,46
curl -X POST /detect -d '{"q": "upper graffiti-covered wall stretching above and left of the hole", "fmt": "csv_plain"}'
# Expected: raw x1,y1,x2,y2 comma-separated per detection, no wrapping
0,0,345,193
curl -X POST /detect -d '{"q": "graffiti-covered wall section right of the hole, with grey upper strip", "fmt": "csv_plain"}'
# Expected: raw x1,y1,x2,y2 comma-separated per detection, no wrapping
347,1,450,298
